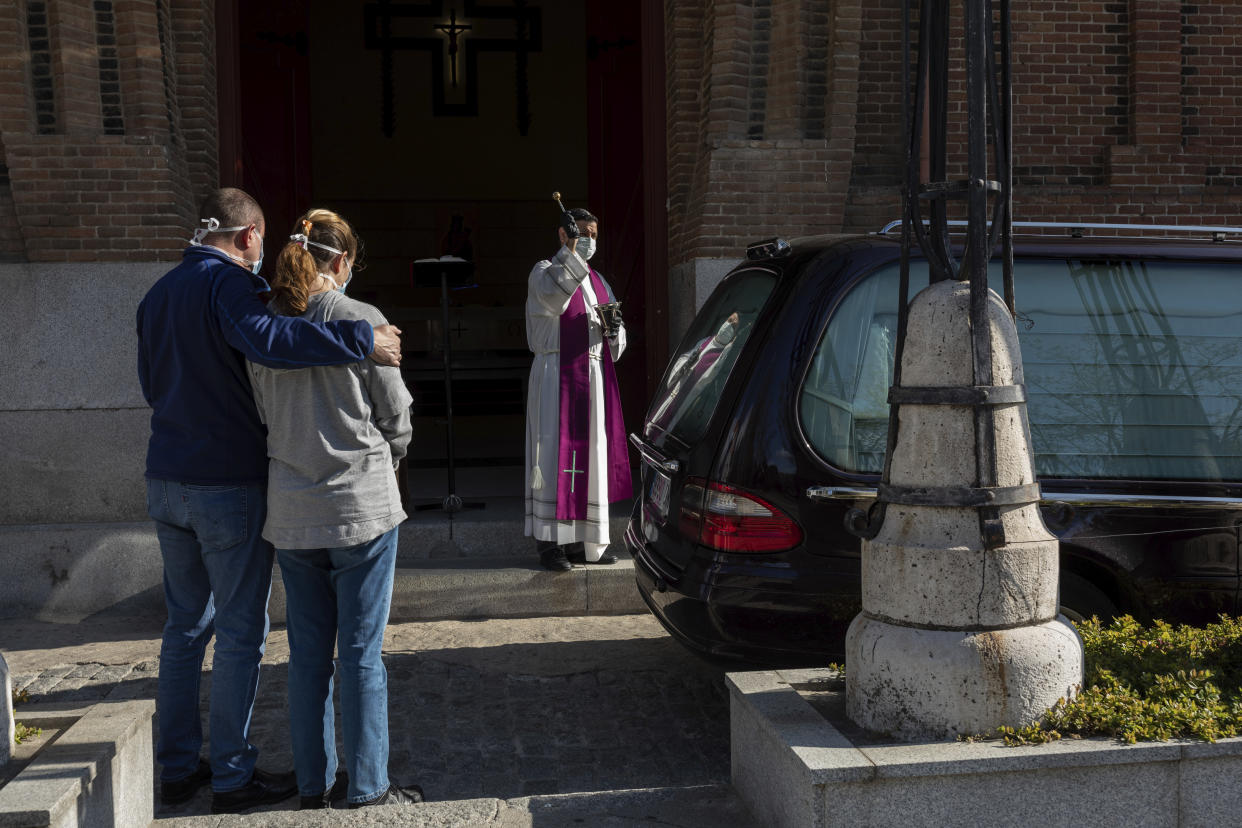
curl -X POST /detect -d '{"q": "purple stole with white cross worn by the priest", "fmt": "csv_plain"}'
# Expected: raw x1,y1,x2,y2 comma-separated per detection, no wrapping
556,271,632,520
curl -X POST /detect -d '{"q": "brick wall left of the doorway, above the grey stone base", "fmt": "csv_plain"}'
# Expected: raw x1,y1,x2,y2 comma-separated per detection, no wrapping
0,0,217,262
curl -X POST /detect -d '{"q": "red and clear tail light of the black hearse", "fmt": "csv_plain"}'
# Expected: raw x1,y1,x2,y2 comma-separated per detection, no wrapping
681,478,802,554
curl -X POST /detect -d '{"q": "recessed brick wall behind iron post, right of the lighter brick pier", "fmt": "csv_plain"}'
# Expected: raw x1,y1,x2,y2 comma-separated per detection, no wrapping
845,0,1242,231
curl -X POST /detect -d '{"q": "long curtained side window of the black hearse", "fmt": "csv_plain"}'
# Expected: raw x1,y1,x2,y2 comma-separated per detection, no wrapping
799,259,1242,480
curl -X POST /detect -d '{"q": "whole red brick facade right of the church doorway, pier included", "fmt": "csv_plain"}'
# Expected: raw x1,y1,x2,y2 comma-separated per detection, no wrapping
666,0,1242,264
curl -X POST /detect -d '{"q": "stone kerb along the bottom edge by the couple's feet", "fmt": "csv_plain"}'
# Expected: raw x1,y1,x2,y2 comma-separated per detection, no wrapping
152,785,759,828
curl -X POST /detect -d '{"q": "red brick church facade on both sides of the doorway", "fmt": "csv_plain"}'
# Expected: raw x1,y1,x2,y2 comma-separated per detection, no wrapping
0,0,1242,266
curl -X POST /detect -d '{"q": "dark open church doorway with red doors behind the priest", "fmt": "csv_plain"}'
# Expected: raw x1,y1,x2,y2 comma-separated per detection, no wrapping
217,0,667,500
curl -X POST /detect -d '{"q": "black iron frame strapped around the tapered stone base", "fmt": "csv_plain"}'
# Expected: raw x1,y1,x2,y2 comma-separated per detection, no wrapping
846,0,1018,549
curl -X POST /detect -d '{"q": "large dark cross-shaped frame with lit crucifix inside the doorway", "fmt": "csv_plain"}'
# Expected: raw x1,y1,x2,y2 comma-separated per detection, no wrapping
363,0,543,138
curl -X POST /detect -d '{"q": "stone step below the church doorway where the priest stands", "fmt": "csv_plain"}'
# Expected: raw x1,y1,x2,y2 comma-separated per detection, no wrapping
0,498,646,622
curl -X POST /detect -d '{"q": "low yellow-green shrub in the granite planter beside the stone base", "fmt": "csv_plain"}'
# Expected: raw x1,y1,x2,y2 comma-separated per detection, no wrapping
999,616,1242,745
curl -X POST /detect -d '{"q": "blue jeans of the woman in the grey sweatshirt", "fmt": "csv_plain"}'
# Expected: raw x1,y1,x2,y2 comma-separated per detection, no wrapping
276,529,397,802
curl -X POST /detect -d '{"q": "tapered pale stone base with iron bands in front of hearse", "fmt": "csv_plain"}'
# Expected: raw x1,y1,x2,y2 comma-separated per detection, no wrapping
846,279,1083,740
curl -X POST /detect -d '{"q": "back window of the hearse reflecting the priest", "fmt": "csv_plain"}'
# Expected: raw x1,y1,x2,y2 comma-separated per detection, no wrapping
646,271,776,444
